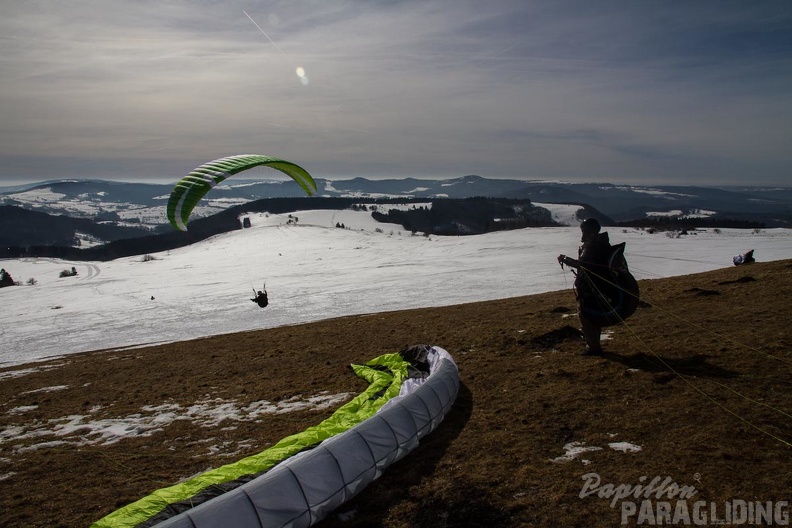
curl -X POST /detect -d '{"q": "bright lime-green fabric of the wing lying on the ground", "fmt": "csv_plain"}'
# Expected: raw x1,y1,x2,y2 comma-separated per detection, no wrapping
91,353,410,528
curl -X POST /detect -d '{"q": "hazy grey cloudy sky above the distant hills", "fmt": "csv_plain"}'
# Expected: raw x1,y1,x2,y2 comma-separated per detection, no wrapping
0,0,792,185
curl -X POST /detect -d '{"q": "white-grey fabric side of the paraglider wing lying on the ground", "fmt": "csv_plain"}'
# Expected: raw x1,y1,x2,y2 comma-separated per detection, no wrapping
157,347,459,528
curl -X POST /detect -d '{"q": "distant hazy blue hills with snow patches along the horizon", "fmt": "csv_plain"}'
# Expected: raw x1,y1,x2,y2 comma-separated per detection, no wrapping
0,176,792,223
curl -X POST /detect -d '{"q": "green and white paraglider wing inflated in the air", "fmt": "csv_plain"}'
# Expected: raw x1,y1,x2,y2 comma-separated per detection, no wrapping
168,154,316,231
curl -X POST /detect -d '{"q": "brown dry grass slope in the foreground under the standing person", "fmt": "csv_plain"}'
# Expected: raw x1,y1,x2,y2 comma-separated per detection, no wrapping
0,260,792,528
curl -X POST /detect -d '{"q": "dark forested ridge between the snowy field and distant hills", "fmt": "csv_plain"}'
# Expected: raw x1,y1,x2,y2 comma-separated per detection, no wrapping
0,197,557,261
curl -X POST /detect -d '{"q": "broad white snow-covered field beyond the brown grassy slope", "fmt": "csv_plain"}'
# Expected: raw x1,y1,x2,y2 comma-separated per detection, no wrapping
0,210,792,366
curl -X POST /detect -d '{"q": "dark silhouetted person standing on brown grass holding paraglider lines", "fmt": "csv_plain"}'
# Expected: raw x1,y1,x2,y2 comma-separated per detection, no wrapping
558,218,611,354
